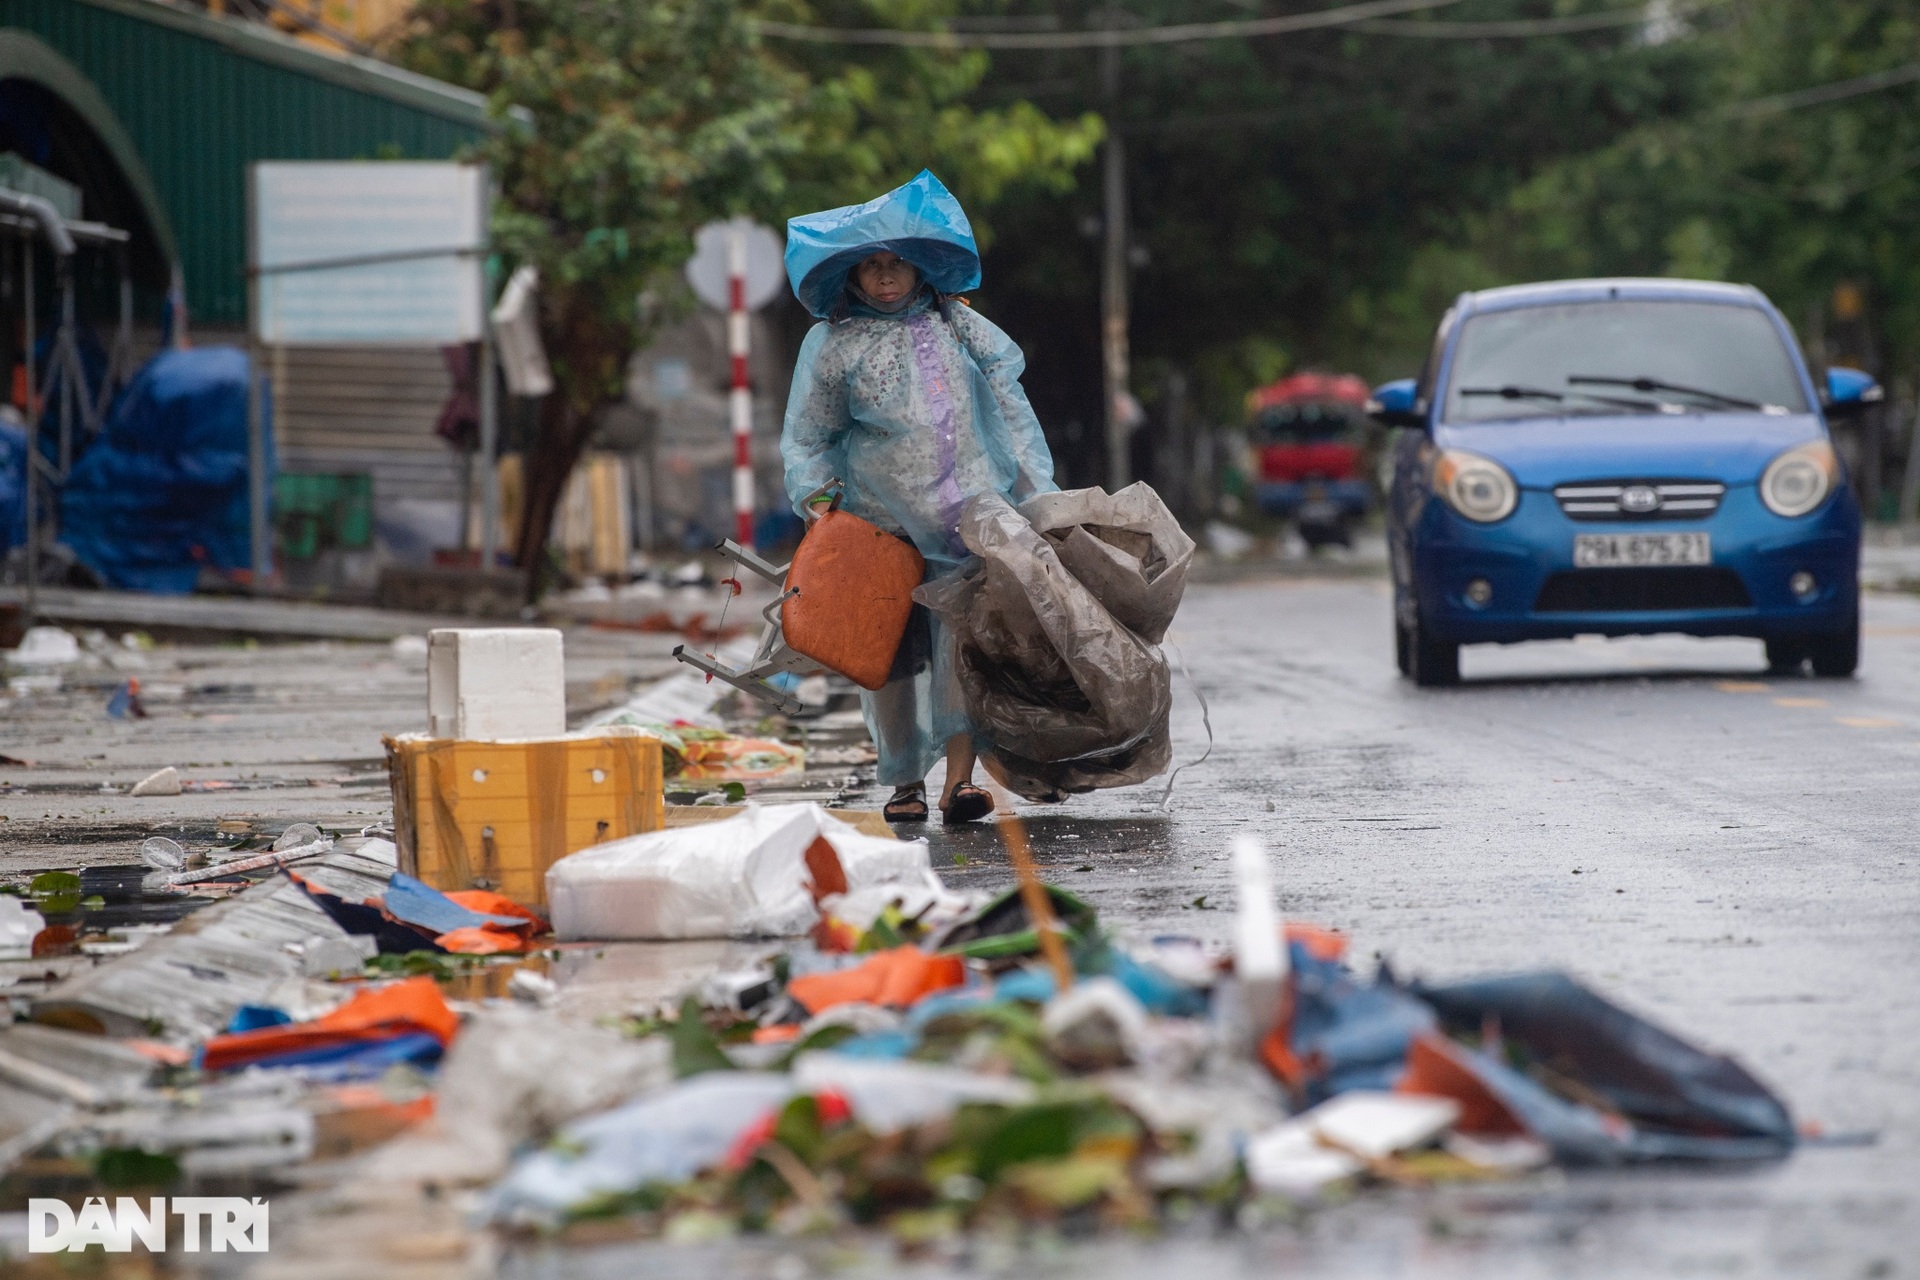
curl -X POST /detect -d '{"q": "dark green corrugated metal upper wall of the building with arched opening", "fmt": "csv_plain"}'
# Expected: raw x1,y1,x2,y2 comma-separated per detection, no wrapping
0,0,495,324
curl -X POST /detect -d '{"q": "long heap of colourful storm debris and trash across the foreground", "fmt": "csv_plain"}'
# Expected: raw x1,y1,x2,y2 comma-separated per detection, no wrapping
0,804,1795,1249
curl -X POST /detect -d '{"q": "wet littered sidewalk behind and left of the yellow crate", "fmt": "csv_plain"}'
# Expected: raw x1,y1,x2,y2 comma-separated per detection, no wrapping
0,628,680,877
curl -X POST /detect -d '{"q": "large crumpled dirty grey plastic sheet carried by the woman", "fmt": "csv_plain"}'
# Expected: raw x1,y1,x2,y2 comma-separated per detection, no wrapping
916,484,1194,800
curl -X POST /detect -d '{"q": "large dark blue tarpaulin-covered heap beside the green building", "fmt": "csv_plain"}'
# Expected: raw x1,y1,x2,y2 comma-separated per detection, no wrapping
60,347,273,593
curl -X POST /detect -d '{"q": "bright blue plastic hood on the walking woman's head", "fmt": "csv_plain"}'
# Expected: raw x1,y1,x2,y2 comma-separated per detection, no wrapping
787,169,979,319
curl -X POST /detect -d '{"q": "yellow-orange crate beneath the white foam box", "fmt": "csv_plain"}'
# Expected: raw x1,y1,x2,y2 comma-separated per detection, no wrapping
386,727,666,908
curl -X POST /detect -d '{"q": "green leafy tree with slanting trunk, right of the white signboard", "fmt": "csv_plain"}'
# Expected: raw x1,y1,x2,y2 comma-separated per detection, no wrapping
396,0,1100,591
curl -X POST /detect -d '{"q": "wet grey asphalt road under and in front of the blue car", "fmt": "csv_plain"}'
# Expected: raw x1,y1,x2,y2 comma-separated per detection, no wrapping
860,580,1920,1278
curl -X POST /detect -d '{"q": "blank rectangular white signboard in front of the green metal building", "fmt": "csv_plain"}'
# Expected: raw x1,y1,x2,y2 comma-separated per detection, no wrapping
248,161,488,345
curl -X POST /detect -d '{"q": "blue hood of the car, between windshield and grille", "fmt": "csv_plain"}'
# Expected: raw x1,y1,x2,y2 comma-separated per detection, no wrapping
1434,413,1826,489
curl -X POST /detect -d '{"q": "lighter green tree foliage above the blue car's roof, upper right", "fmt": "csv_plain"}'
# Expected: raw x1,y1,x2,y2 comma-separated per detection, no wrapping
1465,0,1920,372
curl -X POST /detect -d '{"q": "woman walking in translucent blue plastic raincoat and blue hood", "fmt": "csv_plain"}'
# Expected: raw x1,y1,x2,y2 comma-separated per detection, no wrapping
780,171,1056,821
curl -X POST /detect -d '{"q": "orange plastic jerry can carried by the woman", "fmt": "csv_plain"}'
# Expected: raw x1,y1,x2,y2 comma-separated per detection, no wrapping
780,507,927,689
